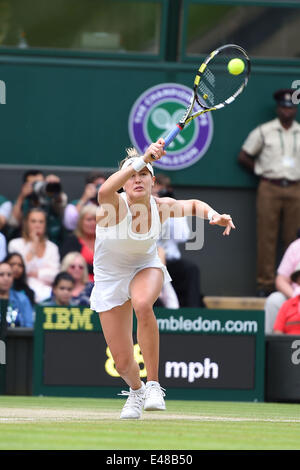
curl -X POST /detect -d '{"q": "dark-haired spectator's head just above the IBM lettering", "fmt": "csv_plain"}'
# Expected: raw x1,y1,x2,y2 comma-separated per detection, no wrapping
41,271,75,306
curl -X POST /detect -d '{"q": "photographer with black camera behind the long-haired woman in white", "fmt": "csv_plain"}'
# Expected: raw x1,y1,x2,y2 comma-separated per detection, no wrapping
9,170,68,244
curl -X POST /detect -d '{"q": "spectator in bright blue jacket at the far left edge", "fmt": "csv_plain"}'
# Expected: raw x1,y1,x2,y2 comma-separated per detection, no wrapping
0,261,34,328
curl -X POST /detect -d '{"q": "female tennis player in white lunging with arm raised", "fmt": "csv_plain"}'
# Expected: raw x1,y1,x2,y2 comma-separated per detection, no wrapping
91,139,235,419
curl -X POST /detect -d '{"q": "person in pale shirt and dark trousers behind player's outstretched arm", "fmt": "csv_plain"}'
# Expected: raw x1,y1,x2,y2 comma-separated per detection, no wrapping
153,174,205,307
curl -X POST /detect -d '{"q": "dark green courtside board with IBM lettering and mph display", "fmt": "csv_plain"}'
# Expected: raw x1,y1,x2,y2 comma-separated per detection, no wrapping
33,307,264,401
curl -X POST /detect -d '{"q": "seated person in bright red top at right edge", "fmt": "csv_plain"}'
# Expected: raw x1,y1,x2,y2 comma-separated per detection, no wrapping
273,263,300,335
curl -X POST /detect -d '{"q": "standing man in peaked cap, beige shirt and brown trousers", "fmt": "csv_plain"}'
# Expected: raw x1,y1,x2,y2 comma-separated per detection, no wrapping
238,89,300,297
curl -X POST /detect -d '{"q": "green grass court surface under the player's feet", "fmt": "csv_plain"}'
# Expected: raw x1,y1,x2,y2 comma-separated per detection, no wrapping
0,396,300,450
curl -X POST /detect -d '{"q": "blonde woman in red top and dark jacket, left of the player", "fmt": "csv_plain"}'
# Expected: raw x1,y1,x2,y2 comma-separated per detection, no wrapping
60,204,97,282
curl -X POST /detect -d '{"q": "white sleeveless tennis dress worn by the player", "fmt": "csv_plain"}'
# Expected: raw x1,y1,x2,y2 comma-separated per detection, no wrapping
90,192,172,312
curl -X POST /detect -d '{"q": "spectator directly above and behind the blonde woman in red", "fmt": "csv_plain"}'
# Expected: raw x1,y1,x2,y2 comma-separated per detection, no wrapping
64,171,106,232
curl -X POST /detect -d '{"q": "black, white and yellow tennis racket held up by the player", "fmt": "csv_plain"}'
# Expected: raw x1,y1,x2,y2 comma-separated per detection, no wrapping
154,44,251,153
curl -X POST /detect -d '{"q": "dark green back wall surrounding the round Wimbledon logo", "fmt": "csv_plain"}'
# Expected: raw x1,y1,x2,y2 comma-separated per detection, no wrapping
0,55,300,187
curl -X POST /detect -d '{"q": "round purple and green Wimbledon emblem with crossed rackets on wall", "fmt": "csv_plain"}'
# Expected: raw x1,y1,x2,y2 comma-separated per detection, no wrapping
129,83,213,170
